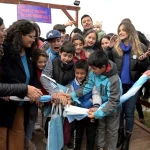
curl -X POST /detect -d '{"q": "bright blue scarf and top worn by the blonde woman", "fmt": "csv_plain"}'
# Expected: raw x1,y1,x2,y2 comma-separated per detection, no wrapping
120,42,132,84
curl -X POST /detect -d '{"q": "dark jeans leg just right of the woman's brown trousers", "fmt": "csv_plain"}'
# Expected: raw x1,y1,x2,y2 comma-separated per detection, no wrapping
25,104,38,141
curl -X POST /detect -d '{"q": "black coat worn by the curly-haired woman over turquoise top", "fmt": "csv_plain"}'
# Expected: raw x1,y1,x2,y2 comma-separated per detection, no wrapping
0,43,33,127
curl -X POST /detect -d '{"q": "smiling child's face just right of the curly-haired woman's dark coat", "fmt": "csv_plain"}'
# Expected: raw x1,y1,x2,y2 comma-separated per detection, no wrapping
36,56,47,70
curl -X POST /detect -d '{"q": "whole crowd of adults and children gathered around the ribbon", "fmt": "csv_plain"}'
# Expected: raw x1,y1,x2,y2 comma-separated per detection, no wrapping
0,15,150,150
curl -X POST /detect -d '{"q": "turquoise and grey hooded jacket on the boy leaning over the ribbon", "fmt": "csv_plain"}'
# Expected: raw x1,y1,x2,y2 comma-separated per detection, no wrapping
71,61,122,116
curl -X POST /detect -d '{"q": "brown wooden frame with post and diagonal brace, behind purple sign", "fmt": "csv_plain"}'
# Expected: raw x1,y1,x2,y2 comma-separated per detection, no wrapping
0,0,80,27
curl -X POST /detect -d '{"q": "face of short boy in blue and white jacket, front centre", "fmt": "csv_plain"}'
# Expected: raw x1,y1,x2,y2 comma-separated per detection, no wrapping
75,68,87,82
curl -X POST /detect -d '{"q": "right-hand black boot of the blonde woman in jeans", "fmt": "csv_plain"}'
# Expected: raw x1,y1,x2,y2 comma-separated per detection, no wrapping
121,131,132,150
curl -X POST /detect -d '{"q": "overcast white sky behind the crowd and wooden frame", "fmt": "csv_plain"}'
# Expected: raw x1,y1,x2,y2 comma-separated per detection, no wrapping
0,0,150,38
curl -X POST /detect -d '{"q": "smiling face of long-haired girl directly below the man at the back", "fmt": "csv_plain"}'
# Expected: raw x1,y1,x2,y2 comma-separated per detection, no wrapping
84,33,96,46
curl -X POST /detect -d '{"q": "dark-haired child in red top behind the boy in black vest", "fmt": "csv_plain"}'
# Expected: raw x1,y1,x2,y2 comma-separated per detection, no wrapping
72,33,87,63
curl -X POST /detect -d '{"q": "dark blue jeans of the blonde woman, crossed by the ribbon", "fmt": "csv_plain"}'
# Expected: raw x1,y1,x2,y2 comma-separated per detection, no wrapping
120,84,139,132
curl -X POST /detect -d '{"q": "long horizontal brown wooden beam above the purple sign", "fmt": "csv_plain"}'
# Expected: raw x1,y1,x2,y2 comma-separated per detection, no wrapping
0,0,80,11
